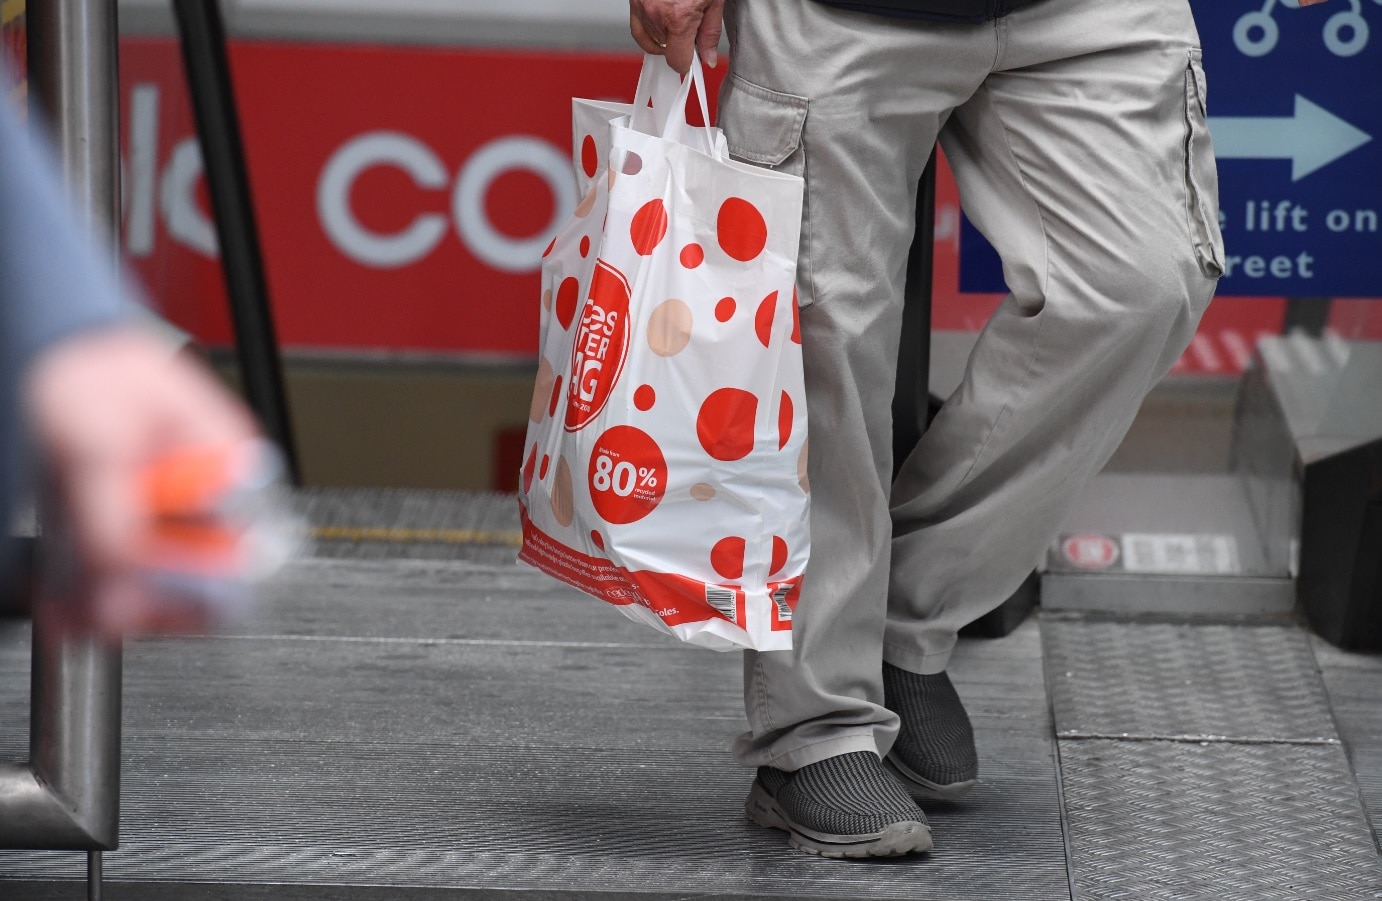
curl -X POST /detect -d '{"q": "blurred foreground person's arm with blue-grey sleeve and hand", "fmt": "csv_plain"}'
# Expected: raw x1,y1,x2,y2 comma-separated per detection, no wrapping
0,84,256,640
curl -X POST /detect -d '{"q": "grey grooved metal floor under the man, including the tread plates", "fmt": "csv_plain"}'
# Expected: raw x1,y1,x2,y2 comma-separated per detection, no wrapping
0,497,1382,901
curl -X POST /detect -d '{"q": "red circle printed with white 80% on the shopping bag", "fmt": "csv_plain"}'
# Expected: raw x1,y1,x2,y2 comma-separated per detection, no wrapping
587,426,668,525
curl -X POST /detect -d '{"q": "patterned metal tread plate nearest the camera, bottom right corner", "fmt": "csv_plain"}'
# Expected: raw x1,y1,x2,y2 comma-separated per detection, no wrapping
1060,739,1382,901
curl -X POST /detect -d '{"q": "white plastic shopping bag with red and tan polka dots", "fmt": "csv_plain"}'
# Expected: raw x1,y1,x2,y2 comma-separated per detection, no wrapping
520,57,810,651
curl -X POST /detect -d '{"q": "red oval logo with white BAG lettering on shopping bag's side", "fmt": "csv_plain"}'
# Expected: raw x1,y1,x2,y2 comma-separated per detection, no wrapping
567,260,629,431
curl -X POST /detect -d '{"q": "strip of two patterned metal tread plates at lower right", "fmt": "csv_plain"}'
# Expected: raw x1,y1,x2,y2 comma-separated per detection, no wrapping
1042,615,1382,901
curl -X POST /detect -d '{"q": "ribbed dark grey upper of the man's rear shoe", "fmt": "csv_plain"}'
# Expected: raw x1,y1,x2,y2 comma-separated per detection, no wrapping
883,663,978,785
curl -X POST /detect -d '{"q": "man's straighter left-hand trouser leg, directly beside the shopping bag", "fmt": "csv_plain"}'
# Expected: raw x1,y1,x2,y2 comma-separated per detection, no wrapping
721,0,996,770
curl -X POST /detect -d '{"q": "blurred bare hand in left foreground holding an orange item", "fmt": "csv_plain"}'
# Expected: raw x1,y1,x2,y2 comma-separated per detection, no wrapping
23,328,257,638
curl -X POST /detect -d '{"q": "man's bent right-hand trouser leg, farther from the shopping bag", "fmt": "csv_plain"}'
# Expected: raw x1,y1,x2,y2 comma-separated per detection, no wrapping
884,0,1223,668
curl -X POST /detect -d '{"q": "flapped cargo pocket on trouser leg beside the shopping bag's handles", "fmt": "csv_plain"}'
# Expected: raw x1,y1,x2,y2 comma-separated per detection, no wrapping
720,72,814,307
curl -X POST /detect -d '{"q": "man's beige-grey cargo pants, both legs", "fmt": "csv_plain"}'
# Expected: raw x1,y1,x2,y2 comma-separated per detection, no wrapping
720,0,1223,770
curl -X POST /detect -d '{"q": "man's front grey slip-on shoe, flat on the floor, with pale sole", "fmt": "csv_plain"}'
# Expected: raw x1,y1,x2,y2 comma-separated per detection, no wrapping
744,752,931,857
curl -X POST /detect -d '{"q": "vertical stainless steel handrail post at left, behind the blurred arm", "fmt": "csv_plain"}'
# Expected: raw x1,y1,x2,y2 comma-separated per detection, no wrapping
0,0,123,901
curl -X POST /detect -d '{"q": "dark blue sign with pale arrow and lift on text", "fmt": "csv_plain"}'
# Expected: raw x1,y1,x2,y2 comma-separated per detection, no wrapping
960,0,1382,297
